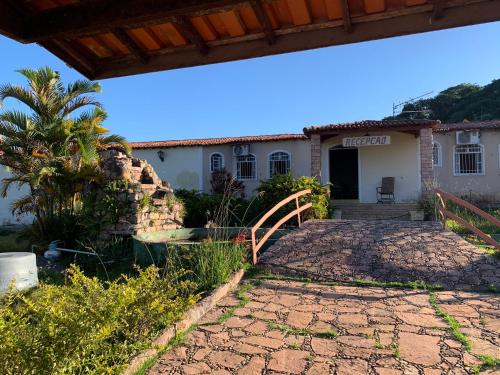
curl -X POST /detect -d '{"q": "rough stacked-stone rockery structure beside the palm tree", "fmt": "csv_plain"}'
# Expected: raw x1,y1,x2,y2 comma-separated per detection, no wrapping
97,150,183,238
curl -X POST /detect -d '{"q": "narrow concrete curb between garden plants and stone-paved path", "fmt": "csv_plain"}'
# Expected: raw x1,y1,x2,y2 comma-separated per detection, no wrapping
122,270,245,375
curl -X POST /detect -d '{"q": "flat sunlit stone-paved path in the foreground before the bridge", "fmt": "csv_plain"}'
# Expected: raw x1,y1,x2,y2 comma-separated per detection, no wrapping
150,281,500,375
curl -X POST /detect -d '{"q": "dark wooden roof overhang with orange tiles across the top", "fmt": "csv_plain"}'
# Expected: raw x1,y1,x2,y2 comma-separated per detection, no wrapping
0,0,500,79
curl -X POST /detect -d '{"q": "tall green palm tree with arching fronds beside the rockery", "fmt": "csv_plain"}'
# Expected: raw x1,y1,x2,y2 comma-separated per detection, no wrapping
0,67,130,231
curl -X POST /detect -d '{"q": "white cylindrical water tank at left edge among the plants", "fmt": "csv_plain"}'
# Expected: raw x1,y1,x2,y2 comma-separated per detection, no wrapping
0,253,38,294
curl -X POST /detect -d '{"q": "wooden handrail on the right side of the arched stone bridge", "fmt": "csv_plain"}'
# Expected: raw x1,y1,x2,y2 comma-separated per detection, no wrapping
435,189,500,250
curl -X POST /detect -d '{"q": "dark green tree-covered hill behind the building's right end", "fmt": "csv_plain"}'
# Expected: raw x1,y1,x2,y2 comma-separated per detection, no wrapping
386,79,500,123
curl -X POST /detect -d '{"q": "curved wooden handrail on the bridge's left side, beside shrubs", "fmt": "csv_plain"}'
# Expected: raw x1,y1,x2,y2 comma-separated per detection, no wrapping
252,189,312,264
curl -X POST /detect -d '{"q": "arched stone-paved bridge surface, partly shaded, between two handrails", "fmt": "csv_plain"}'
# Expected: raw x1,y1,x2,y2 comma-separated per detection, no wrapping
259,220,500,290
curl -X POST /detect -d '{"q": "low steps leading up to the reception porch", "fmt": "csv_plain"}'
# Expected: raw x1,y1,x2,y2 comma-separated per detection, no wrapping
332,201,418,220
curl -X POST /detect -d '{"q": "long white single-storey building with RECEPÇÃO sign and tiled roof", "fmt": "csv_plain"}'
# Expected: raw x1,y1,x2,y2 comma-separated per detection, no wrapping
0,120,500,223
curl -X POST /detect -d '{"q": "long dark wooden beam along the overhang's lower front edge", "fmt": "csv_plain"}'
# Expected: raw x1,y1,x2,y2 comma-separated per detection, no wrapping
91,1,500,78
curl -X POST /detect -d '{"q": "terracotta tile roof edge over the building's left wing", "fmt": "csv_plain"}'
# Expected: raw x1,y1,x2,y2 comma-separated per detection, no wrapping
129,134,307,149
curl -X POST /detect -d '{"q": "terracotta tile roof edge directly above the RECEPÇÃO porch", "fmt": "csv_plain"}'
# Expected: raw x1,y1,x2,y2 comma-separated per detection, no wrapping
304,120,439,135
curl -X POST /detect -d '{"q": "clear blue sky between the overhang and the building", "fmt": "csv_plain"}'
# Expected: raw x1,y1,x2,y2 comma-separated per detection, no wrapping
0,22,500,141
